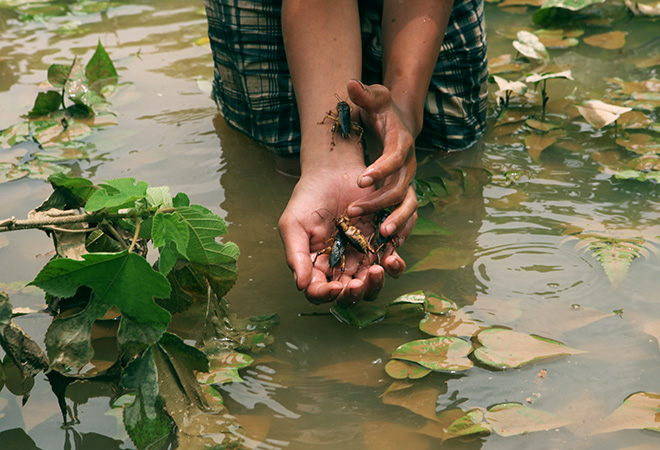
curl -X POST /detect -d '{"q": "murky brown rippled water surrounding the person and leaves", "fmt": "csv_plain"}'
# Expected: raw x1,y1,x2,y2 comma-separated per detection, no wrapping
0,0,660,450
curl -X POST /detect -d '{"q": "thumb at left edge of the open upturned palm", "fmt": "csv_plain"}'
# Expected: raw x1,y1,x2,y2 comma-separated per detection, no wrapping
278,217,312,291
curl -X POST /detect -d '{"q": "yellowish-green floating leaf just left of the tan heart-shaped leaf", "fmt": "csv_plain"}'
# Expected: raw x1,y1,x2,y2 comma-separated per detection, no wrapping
392,337,472,373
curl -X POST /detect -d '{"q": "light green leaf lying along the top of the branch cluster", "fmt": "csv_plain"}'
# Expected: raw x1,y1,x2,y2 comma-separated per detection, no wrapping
85,178,149,212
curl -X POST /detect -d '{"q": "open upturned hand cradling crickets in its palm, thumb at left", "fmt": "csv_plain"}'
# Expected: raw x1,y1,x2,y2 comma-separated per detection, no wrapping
278,164,405,305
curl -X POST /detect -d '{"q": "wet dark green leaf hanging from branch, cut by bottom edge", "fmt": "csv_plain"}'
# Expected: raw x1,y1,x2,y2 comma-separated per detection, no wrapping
121,348,173,450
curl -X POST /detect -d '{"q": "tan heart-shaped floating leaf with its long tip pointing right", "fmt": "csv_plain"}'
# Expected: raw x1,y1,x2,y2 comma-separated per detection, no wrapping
474,327,585,368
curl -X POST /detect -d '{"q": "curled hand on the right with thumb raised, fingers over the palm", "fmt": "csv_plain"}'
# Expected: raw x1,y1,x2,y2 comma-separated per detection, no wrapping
347,80,419,248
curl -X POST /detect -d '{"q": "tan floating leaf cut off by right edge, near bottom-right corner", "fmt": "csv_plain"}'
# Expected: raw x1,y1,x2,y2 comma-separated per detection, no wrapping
594,392,660,434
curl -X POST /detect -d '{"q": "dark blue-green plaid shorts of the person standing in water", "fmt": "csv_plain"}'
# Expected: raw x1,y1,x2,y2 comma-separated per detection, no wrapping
204,0,488,154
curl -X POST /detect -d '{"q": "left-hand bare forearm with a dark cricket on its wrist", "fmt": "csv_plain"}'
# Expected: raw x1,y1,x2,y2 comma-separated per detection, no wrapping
282,0,362,175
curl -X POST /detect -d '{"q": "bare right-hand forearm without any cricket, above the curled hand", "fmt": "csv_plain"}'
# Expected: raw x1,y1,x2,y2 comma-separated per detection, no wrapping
382,0,453,137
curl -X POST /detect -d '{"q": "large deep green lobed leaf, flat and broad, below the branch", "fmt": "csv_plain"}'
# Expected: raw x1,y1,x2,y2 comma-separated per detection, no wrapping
30,251,170,331
